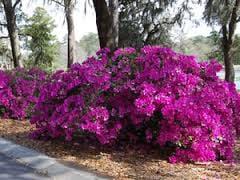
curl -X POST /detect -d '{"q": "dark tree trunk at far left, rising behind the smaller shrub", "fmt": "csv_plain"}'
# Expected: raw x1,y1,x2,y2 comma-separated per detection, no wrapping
0,0,22,67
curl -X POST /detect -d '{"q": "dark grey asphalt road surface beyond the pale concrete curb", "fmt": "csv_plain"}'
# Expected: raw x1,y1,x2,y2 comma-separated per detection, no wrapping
0,154,50,180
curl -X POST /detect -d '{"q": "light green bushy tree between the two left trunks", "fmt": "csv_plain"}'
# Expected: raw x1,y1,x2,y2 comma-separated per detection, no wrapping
23,7,58,69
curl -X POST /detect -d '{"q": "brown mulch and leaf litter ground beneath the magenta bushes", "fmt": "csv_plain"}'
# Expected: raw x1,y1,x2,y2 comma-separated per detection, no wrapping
0,120,240,180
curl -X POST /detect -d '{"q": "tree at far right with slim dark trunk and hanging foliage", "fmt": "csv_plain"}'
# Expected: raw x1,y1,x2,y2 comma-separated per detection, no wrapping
204,0,240,82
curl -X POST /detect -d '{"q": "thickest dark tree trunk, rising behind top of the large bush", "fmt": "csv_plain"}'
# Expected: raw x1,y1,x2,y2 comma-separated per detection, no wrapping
93,0,119,50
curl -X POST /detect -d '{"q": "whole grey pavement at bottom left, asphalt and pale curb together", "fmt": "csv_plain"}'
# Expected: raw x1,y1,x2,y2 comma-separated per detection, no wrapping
0,137,110,180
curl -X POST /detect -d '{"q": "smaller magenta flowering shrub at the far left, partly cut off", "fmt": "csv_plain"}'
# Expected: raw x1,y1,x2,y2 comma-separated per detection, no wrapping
0,69,46,119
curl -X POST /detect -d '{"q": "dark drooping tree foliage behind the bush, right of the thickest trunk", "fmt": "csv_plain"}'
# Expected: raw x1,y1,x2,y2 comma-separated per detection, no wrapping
119,0,190,48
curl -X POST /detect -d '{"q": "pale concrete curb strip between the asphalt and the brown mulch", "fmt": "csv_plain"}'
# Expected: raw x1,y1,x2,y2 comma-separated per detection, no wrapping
0,137,107,180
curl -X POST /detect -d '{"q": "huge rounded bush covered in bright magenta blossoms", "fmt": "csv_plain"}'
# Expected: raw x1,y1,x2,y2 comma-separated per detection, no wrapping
31,46,240,163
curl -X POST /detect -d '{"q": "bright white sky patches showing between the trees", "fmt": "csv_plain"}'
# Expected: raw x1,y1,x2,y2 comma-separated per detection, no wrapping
22,0,240,40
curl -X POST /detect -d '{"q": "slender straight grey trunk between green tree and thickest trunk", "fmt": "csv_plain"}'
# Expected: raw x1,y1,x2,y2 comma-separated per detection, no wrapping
64,0,75,68
